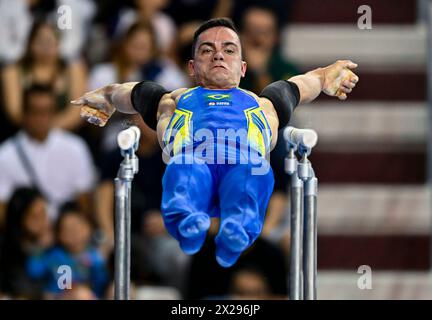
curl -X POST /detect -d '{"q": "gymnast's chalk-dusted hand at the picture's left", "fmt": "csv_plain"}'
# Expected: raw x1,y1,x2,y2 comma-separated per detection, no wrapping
71,85,116,127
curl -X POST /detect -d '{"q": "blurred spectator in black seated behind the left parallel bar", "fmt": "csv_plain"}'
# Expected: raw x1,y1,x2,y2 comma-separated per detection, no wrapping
96,126,188,294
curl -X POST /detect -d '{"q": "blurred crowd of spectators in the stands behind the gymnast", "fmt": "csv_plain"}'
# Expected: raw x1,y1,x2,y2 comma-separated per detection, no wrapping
0,0,300,299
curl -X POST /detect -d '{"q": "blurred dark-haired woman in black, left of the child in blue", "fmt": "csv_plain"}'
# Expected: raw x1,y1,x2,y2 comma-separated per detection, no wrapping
0,188,53,299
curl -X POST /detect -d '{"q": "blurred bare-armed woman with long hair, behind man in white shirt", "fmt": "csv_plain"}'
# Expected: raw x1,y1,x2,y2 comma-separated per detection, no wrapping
2,22,87,130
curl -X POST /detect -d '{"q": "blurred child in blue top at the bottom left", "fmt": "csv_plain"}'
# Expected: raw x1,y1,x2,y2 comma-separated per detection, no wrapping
27,203,109,299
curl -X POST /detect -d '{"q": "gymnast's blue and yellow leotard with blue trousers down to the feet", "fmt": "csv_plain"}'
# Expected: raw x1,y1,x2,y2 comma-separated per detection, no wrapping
161,87,274,267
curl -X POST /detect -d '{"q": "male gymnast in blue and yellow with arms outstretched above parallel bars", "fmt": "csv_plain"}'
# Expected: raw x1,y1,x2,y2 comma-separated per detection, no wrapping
72,18,359,267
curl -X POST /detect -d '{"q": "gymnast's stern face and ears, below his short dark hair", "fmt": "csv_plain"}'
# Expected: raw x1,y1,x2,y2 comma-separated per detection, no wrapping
189,27,246,89
